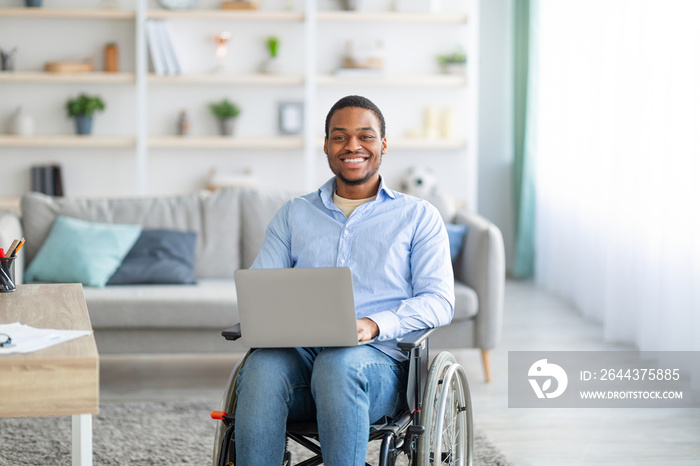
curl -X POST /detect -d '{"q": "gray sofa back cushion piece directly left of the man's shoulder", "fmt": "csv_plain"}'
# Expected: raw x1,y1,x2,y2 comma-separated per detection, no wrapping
241,189,298,269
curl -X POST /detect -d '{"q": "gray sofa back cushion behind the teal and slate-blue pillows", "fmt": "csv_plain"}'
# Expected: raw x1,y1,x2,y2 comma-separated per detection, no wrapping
21,188,240,278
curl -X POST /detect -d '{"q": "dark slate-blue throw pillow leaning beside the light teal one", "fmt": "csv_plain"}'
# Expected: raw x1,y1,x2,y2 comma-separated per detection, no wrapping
107,230,197,285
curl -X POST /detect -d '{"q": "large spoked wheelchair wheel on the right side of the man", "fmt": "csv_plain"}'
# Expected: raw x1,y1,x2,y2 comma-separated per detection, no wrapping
417,351,474,466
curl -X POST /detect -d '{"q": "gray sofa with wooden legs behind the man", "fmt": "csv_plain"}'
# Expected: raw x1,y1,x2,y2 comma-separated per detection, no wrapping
0,188,505,379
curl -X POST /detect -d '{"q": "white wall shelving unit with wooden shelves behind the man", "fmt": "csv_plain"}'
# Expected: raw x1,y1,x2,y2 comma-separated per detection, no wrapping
0,0,478,206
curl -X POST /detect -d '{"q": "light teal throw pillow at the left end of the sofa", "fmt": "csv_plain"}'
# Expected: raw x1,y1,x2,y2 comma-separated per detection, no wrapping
25,215,142,287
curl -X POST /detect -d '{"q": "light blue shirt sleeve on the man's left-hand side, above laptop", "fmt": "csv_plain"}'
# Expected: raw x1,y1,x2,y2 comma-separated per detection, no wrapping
250,202,294,269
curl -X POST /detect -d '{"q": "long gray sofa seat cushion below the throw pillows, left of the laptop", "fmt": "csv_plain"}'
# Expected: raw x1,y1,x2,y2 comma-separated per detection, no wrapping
85,278,239,330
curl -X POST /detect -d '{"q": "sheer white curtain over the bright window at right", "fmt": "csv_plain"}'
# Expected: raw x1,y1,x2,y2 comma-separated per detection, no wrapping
532,0,700,350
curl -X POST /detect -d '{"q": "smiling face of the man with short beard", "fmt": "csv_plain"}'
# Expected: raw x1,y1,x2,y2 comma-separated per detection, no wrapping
323,107,386,195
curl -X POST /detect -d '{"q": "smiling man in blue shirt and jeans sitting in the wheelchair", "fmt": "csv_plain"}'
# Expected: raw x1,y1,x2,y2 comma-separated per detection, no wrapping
235,96,454,466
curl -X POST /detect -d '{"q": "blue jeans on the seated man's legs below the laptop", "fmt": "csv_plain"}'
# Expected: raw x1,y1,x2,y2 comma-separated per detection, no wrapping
235,346,408,466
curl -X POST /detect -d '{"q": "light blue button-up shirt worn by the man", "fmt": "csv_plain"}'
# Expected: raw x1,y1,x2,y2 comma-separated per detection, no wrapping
251,178,455,359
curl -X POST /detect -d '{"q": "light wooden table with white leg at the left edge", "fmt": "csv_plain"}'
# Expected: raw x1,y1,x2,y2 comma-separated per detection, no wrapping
0,283,99,465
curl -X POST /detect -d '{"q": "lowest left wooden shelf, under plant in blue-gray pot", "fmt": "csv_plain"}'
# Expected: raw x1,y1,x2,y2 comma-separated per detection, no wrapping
0,134,136,149
